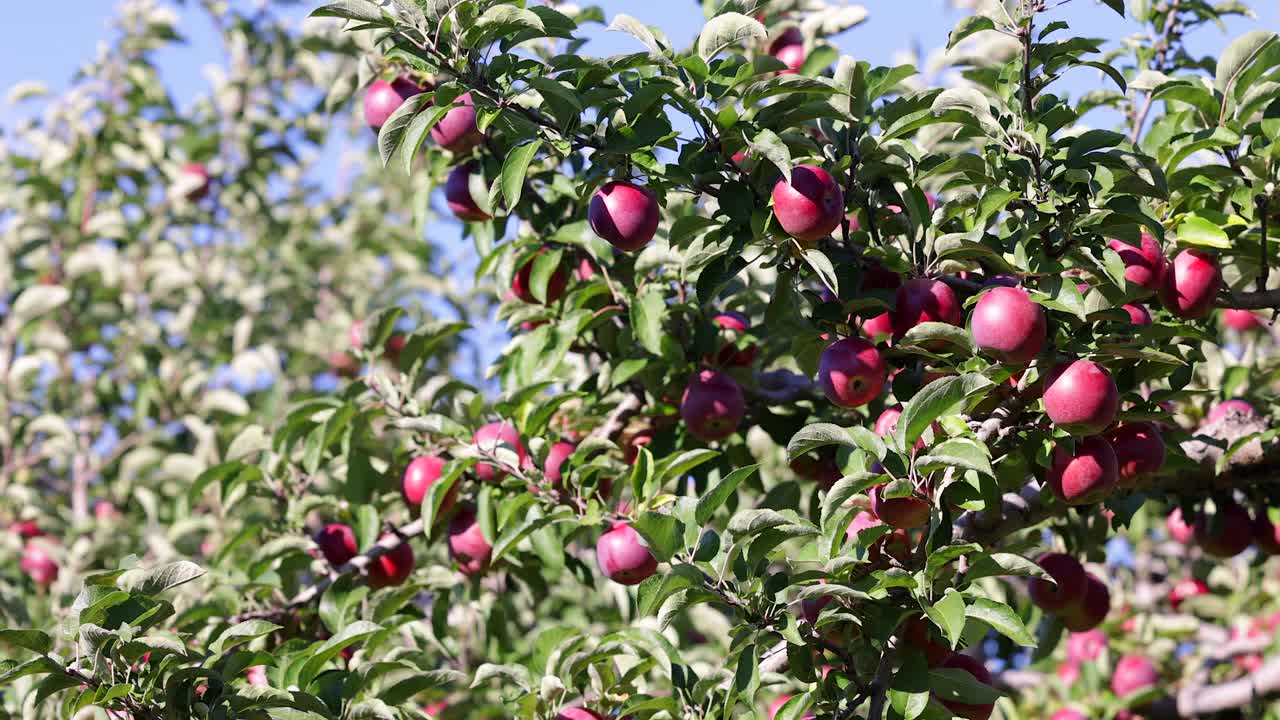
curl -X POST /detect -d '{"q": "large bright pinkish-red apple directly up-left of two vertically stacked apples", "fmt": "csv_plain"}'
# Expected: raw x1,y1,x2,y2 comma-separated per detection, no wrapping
969,287,1047,365
